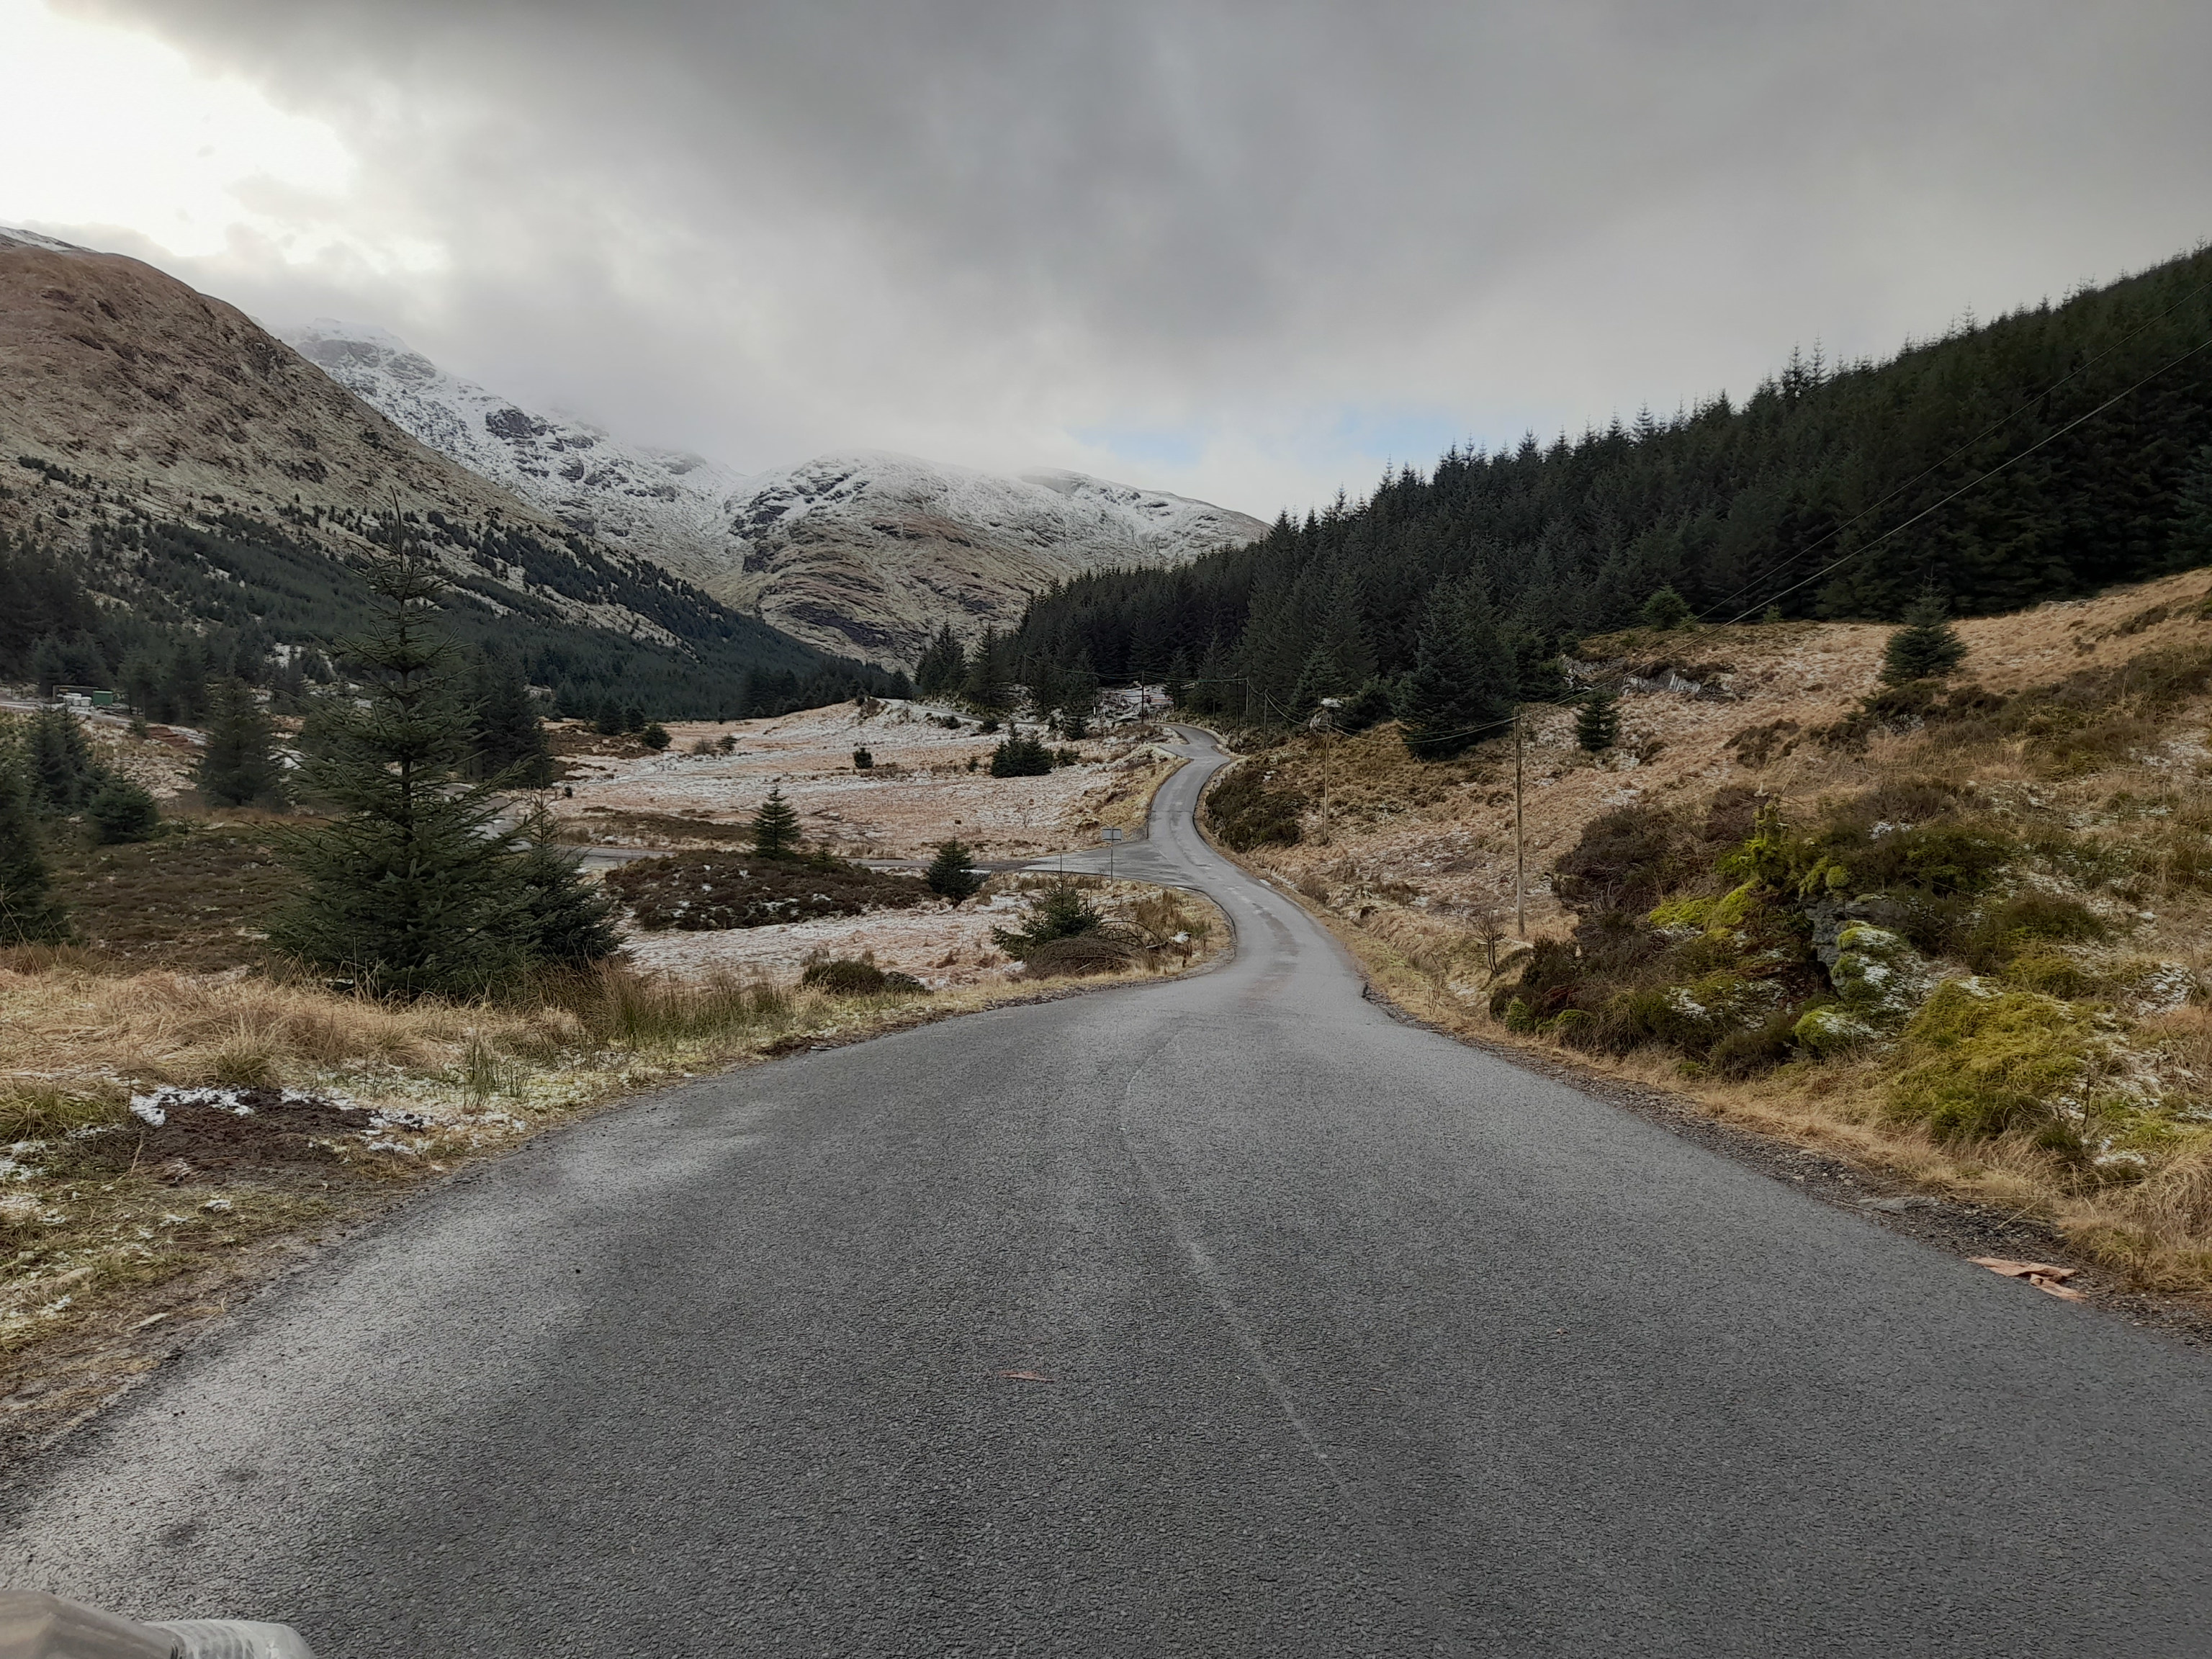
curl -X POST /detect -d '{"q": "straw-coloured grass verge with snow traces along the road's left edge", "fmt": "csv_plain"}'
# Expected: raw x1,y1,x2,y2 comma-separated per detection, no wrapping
0,907,1230,1457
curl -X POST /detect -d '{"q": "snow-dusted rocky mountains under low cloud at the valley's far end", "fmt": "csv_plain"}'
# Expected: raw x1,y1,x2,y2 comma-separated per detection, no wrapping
283,320,1267,666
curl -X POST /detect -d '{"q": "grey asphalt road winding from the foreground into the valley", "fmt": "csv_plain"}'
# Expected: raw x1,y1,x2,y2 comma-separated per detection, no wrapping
0,743,2212,1659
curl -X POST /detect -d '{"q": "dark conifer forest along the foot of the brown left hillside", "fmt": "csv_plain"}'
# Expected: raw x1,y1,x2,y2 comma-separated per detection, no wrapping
0,490,904,724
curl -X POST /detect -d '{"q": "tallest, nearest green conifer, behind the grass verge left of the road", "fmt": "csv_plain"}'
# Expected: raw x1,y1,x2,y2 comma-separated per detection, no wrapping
270,544,537,995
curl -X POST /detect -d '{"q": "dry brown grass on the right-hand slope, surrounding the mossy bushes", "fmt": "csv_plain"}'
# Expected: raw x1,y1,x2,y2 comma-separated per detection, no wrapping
1246,571,2212,1296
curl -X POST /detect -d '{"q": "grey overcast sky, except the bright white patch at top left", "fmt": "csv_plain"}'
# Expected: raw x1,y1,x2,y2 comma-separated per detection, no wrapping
17,0,2212,516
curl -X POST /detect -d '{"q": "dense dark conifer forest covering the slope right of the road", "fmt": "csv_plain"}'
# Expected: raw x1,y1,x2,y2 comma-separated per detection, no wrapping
1002,250,2212,730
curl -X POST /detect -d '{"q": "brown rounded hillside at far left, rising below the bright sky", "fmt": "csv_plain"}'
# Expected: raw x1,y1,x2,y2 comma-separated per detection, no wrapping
0,230,858,712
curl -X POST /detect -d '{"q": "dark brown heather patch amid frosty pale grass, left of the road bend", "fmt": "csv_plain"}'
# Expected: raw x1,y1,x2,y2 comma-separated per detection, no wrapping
606,852,935,933
